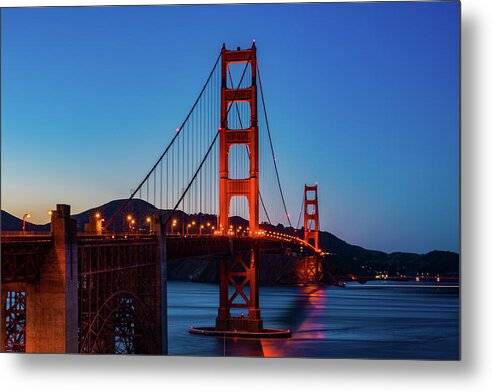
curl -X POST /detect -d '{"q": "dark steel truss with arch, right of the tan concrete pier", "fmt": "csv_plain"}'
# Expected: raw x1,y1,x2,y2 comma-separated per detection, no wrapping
78,240,161,354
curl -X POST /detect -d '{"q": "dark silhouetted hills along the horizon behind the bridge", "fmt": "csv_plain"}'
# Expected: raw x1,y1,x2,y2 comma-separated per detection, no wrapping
1,199,459,275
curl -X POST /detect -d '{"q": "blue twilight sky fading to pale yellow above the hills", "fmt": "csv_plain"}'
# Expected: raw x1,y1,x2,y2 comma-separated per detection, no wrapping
1,1,460,252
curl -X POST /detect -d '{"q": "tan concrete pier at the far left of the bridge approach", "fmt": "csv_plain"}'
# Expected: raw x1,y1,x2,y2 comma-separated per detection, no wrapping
1,204,78,353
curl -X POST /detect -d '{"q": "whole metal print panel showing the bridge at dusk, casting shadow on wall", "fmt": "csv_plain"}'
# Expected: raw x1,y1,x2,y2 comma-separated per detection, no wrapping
0,1,460,360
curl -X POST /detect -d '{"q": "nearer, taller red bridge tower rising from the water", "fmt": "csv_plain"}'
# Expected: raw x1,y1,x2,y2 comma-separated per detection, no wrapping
216,43,263,332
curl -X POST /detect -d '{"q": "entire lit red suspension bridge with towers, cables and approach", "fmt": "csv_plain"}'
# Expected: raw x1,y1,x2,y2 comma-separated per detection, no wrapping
0,42,326,354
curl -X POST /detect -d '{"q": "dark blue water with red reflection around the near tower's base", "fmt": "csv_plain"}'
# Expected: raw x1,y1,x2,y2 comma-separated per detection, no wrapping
168,282,459,359
